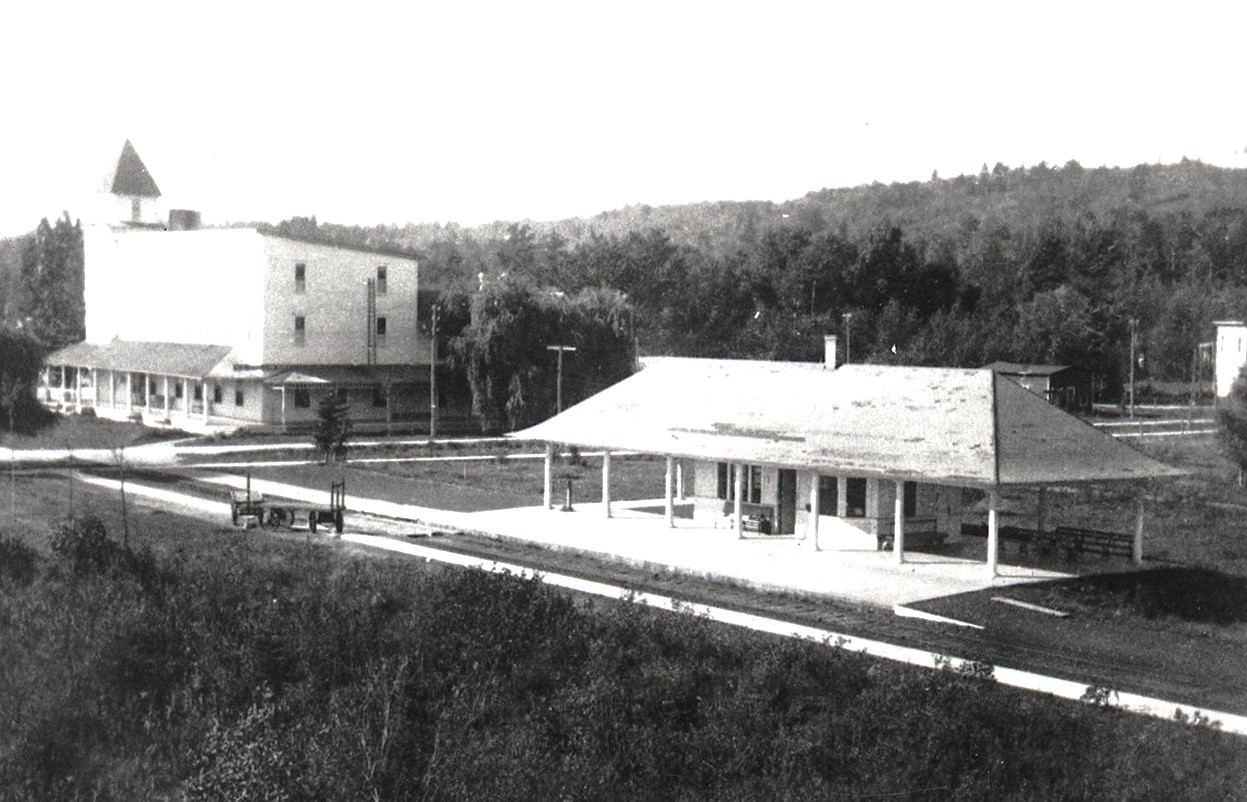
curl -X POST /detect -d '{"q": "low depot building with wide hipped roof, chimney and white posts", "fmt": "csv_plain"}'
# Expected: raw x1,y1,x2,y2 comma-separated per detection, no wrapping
513,337,1182,575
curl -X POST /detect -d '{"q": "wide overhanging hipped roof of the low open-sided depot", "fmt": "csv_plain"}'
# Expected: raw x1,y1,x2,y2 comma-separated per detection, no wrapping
513,358,1182,486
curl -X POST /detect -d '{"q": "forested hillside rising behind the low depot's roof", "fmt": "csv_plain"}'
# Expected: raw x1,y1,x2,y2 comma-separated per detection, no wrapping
282,161,1247,399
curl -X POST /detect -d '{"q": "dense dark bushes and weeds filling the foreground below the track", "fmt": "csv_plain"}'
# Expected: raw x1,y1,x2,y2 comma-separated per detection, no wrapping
0,530,1247,800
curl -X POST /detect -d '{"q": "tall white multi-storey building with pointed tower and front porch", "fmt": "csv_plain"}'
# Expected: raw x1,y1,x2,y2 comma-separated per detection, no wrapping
40,142,430,429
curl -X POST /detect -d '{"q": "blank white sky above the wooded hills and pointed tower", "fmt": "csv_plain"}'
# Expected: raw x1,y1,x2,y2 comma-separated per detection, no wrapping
0,0,1247,236
